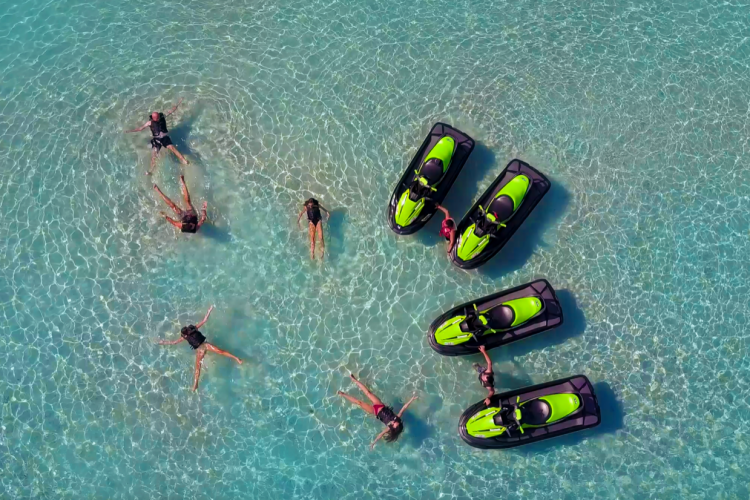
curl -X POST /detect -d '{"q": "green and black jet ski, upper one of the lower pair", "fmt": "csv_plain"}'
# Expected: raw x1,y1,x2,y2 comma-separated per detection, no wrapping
427,279,563,356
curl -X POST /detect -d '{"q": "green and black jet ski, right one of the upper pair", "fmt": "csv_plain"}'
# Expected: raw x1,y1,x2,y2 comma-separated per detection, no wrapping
450,160,550,269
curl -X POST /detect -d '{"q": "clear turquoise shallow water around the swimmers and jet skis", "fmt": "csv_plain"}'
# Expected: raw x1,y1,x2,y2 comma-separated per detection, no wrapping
0,0,750,499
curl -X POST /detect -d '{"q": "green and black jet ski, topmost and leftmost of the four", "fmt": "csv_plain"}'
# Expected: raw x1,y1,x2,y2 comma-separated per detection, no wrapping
388,123,474,234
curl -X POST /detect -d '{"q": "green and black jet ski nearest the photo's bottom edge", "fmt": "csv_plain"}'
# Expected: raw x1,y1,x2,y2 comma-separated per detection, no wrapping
458,375,601,448
